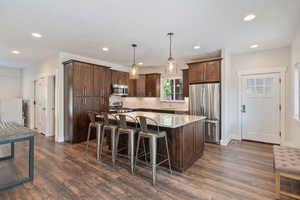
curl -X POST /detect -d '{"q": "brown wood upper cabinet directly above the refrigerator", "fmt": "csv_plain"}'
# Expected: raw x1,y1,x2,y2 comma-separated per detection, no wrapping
188,58,221,84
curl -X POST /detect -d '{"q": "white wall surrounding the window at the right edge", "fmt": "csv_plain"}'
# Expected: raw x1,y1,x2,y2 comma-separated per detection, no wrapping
285,29,300,148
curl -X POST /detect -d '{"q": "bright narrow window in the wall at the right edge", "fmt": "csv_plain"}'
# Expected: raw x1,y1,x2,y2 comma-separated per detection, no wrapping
294,63,300,120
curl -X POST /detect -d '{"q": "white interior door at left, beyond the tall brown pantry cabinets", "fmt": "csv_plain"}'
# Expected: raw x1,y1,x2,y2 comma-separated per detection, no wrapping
35,78,47,134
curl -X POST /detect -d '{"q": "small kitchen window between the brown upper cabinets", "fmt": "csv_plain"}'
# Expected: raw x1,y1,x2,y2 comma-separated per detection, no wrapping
161,78,184,101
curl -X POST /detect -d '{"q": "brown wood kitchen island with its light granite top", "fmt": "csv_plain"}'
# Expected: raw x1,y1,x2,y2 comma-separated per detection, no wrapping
98,112,205,172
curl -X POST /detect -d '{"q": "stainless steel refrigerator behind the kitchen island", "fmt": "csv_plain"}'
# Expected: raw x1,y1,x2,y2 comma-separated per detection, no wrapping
189,83,221,144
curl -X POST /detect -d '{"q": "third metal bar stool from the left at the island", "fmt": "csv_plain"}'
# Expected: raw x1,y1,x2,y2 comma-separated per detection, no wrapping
116,114,139,174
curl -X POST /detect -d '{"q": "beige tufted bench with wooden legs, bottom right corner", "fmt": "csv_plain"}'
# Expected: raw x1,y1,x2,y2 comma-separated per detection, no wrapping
273,146,300,199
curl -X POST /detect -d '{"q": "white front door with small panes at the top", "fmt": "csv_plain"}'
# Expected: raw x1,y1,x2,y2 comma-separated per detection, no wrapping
241,73,280,144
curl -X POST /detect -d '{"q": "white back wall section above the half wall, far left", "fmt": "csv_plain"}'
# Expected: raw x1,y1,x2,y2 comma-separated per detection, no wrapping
0,66,22,99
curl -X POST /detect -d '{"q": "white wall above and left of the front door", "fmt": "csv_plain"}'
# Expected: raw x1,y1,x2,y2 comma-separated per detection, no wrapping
227,47,290,143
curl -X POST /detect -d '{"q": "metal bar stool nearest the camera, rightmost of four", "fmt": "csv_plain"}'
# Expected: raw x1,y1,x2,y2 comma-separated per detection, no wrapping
135,116,172,185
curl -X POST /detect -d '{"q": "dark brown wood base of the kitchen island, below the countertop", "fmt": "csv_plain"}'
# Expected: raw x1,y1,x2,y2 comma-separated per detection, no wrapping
158,120,205,172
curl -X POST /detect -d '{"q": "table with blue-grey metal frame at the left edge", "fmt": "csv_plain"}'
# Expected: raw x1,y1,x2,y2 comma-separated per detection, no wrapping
0,121,35,190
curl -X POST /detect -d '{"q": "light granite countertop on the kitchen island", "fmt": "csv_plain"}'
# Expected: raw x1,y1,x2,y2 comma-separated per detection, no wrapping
97,111,206,128
